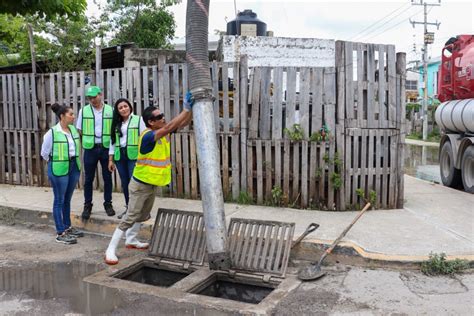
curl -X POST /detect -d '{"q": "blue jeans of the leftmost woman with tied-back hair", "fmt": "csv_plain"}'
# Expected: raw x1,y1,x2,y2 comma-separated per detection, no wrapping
48,161,80,234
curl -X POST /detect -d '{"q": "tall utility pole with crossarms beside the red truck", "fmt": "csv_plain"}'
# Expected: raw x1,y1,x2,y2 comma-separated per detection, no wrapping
409,0,441,140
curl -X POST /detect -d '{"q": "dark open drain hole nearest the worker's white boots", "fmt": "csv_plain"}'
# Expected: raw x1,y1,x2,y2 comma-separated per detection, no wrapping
117,266,188,287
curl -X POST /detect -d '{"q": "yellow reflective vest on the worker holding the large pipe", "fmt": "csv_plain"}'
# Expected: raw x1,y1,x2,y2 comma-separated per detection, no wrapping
133,129,171,186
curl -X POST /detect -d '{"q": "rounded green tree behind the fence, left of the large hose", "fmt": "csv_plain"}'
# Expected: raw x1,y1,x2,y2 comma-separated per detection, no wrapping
105,0,176,48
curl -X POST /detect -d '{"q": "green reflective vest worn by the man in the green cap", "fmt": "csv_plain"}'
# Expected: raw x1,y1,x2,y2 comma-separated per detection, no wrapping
82,104,114,149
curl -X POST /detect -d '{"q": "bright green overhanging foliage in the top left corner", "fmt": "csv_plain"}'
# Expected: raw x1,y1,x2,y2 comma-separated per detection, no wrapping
0,0,87,19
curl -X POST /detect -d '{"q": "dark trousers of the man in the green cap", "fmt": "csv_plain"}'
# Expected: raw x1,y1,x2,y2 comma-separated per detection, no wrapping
84,147,112,204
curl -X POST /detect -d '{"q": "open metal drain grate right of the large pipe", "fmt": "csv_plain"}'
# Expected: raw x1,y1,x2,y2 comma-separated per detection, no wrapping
228,218,295,277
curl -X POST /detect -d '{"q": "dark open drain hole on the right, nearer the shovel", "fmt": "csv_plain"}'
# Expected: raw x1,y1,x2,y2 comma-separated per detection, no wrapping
197,280,273,304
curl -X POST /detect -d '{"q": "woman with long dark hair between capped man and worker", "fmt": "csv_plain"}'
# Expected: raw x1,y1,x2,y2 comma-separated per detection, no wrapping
109,99,146,218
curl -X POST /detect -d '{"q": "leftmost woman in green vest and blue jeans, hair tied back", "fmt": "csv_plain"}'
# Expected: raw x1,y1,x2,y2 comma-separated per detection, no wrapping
41,103,84,245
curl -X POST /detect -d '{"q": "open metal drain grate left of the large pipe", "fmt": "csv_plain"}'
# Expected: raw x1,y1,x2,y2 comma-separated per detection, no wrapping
150,208,206,265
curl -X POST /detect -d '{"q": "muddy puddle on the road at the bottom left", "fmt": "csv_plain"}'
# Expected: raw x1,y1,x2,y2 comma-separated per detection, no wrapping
0,261,123,315
